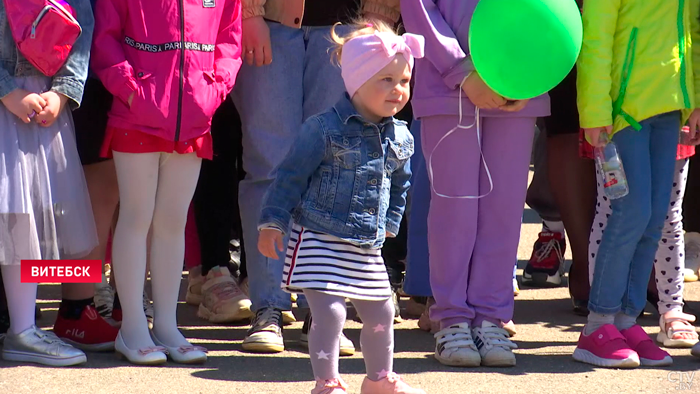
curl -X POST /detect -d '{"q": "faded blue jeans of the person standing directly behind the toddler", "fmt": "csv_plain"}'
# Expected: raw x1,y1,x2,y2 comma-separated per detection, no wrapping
232,22,345,311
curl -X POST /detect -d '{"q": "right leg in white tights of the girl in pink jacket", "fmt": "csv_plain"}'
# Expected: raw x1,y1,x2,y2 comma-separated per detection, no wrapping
150,153,202,346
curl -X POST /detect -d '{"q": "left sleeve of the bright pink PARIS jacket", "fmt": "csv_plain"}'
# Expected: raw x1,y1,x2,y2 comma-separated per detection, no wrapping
91,0,138,105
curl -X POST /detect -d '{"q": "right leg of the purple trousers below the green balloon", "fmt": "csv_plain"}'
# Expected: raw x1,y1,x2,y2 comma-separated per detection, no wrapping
470,118,535,326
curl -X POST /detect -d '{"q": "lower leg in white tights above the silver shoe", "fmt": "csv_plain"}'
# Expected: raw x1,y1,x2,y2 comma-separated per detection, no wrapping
0,265,37,334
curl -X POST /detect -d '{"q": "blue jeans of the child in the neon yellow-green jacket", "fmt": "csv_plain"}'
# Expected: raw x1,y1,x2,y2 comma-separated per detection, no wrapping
588,111,681,317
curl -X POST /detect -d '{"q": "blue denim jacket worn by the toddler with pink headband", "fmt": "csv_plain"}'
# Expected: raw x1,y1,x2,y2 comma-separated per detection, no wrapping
259,94,414,248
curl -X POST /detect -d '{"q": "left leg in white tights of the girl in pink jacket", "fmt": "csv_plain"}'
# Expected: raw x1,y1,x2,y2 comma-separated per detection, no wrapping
112,152,160,350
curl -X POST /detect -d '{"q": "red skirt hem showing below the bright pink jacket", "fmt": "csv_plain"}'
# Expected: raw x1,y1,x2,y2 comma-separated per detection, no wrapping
100,127,214,160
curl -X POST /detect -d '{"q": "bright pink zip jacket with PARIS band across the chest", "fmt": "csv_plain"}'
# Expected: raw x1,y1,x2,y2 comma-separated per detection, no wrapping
91,0,241,141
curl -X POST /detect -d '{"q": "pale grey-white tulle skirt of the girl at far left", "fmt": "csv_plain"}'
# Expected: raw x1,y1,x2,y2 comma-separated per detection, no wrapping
0,77,98,265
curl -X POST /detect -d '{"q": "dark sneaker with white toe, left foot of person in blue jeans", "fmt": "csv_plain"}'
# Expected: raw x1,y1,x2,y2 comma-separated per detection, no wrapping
243,308,284,353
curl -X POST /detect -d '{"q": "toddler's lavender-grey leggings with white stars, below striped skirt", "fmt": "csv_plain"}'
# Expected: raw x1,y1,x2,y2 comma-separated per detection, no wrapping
304,290,394,381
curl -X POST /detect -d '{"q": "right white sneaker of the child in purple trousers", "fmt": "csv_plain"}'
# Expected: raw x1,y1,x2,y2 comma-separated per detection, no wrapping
473,320,518,367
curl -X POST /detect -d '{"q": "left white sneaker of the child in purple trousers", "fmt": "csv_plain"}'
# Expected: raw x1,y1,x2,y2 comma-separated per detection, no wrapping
435,323,481,367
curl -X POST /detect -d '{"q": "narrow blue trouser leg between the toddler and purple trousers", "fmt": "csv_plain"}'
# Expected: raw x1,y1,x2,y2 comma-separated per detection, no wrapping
403,120,433,297
